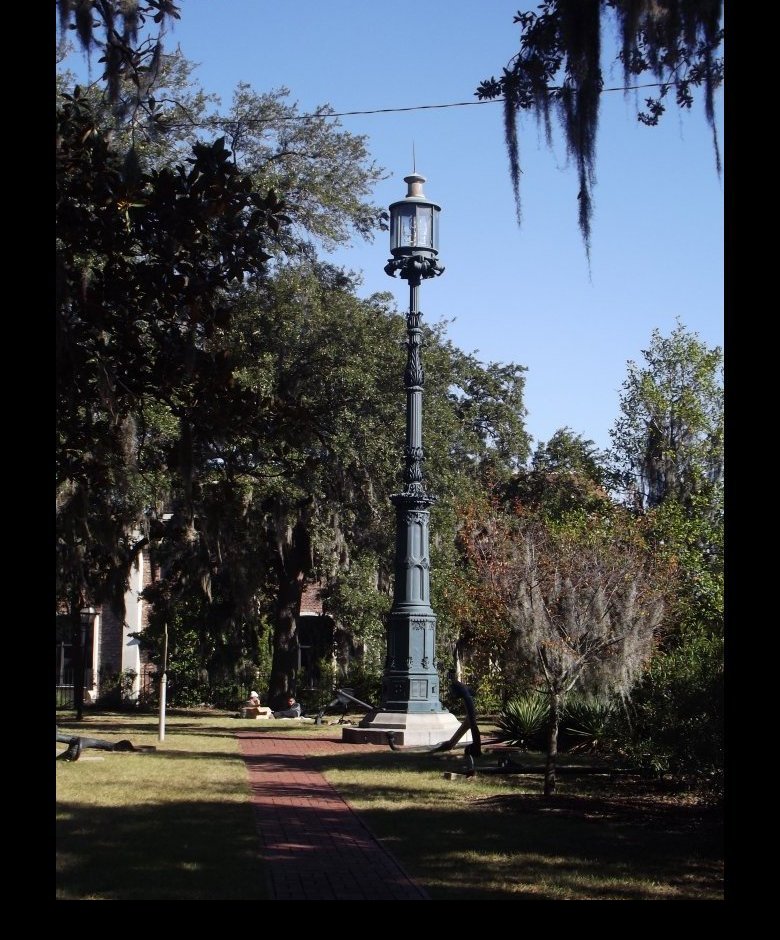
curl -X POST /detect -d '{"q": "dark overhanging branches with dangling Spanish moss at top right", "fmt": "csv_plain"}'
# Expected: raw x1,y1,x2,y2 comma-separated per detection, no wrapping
476,0,723,255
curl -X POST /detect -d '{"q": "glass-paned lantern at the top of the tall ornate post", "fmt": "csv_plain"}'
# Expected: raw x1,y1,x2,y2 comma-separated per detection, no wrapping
385,173,444,280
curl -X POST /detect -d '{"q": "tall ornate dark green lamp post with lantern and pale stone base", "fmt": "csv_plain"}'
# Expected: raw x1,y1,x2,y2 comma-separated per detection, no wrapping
343,173,466,745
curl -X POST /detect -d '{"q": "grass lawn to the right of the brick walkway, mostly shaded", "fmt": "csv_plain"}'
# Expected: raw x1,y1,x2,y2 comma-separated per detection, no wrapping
302,753,723,900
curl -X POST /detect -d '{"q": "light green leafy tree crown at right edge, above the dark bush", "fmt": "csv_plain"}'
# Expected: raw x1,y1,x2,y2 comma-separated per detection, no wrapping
611,323,724,647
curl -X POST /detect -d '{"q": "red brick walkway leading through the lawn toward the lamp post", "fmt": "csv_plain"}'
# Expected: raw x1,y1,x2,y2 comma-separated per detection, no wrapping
238,731,430,901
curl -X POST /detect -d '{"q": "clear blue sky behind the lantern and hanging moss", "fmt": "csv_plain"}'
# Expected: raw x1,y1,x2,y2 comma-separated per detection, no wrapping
62,0,724,456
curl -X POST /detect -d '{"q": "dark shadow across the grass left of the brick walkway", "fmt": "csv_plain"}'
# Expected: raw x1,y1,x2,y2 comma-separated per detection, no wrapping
56,800,270,901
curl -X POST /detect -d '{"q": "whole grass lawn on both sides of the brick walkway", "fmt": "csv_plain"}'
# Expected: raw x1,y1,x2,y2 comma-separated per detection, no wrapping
56,712,723,900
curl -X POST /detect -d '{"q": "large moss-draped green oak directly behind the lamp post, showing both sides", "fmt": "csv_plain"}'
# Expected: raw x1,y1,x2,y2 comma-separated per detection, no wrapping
136,264,527,699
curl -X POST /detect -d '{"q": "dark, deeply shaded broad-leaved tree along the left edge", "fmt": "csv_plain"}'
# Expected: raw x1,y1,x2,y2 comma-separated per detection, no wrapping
56,84,282,712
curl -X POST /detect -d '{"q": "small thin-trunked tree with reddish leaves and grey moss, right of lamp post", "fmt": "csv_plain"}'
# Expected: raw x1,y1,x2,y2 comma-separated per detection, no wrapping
464,512,669,796
